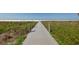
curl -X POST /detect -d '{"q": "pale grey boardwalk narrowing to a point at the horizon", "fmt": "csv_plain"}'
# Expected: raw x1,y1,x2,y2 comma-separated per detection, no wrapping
23,22,58,45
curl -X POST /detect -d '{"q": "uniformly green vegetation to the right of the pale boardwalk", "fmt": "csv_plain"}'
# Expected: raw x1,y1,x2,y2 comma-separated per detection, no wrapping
42,21,79,45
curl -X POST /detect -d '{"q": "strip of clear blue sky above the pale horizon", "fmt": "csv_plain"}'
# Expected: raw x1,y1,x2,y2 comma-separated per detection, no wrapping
0,13,79,20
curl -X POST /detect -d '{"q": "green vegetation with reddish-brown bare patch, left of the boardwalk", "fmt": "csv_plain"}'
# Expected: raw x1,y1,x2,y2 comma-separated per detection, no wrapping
0,22,36,45
